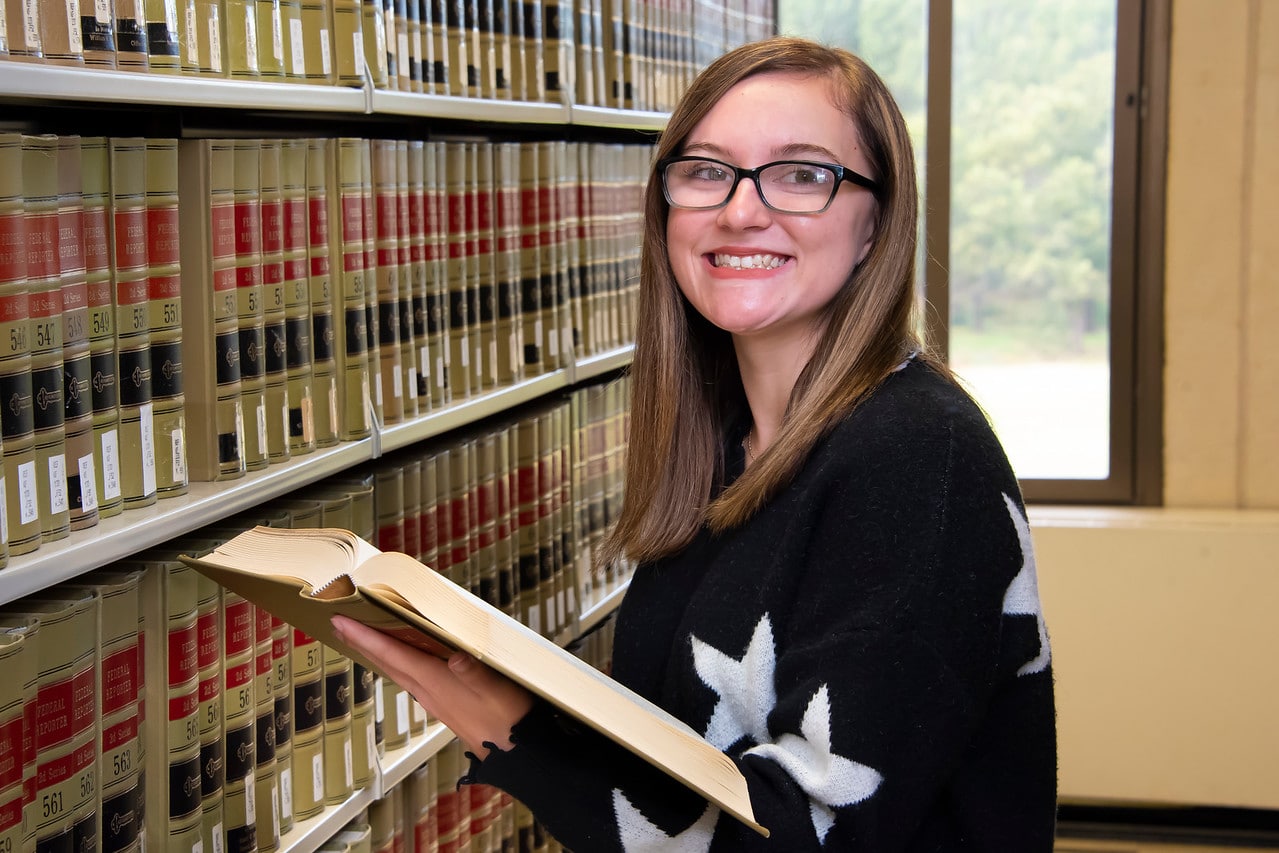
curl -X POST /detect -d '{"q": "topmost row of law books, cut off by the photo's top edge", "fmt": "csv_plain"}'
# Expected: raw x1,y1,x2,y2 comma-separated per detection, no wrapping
0,0,773,110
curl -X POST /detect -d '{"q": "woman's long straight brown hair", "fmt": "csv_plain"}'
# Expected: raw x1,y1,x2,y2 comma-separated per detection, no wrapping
600,37,944,561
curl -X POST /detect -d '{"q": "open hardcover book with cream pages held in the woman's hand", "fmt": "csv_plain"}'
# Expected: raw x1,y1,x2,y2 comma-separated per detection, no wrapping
182,527,769,835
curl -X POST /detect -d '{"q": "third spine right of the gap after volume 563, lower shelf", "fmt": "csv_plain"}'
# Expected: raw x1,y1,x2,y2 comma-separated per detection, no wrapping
221,590,258,850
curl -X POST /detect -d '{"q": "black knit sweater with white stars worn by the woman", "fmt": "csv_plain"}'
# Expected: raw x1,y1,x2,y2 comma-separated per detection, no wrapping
464,362,1056,853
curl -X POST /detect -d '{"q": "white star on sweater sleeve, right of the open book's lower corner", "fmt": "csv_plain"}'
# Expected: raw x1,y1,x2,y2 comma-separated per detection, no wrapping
746,684,884,841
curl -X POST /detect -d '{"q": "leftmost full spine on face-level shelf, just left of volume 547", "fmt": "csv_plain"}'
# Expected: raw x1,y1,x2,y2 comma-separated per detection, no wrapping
0,133,41,555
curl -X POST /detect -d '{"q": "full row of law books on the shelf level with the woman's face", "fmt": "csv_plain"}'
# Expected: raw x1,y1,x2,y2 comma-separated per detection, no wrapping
0,133,650,563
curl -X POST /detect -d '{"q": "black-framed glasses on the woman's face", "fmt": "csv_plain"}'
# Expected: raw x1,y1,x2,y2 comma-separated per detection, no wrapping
657,157,880,214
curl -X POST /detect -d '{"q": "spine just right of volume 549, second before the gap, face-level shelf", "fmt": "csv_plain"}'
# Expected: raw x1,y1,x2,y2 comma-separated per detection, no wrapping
110,138,156,509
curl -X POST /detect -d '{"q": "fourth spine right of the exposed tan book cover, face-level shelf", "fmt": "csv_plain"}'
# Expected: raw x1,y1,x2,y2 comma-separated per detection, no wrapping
280,139,316,454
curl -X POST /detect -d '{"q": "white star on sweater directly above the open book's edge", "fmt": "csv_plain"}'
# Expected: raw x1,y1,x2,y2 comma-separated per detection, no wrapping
689,614,778,749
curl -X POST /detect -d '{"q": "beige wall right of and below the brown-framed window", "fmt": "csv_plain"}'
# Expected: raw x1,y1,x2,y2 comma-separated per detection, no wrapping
1031,0,1279,810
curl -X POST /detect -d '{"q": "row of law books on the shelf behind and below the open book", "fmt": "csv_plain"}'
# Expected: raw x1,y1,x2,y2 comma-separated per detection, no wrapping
0,375,623,853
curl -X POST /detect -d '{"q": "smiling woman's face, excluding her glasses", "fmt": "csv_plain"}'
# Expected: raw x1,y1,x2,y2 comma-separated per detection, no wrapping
666,72,879,347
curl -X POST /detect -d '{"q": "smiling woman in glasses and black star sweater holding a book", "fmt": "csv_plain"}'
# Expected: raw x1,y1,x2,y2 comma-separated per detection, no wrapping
338,38,1055,853
